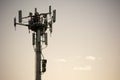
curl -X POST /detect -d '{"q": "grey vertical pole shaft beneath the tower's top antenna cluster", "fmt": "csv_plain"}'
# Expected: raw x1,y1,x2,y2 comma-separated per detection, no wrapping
36,29,41,80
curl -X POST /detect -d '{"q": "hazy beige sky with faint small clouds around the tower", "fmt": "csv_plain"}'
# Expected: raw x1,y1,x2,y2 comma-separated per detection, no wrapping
0,0,120,80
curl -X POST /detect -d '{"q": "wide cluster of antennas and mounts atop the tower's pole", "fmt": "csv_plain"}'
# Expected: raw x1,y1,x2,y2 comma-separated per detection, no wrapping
14,6,56,35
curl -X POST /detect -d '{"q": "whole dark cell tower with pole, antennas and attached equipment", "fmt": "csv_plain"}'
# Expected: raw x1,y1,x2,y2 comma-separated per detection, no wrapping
14,6,56,80
